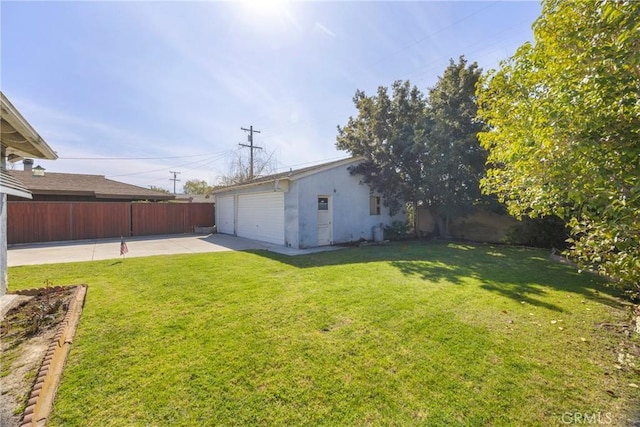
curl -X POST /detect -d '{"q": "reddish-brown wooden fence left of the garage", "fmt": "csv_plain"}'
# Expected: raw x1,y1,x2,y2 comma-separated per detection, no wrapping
7,202,214,244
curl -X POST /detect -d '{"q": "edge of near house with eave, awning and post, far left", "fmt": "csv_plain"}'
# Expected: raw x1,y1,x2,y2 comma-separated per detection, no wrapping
0,92,58,297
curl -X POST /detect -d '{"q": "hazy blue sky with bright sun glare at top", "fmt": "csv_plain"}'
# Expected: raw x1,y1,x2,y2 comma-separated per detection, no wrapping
0,0,540,190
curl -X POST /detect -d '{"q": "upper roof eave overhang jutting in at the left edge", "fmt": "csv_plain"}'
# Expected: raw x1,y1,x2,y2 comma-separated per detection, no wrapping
0,92,58,162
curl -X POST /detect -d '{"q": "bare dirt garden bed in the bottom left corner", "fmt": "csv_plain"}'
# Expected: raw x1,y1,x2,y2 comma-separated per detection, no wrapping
0,286,86,427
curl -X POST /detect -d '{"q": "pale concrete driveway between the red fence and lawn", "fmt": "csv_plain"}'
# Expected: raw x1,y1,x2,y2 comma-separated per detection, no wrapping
8,234,339,267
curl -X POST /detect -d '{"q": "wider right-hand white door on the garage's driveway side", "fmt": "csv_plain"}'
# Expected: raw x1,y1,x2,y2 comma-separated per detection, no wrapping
237,192,284,245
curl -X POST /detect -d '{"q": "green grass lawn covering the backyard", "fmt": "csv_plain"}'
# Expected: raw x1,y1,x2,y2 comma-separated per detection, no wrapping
9,242,640,426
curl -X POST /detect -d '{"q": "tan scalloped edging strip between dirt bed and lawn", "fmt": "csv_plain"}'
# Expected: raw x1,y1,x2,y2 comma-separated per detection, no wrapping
20,285,87,427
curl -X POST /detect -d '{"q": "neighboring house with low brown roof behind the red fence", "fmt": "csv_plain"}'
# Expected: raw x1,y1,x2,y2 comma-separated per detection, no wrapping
8,159,174,202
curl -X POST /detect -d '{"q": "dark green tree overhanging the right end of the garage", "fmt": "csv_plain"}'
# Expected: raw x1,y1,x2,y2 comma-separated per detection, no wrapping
336,57,486,234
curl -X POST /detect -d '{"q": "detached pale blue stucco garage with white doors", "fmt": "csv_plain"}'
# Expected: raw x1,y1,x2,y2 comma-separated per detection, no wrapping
214,158,406,248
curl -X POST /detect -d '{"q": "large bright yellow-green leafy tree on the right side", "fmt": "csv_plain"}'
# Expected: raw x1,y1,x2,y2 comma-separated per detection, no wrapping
479,0,640,287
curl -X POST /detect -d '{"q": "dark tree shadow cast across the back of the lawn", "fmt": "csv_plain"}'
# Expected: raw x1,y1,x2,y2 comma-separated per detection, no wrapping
250,241,622,312
